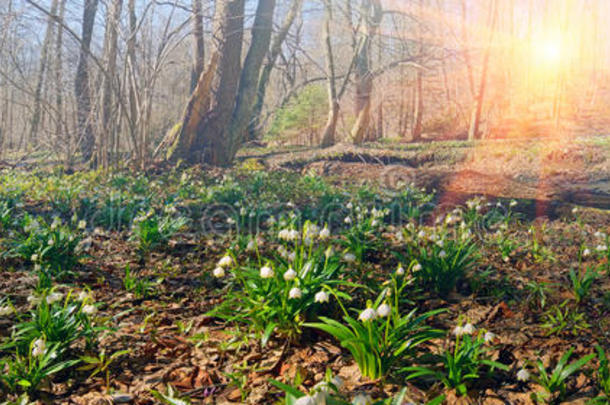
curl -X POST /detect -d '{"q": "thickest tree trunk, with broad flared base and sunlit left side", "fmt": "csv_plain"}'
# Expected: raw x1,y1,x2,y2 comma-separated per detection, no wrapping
167,0,245,166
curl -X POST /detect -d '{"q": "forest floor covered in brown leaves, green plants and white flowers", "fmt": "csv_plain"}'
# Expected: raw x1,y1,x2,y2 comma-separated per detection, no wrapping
0,137,610,404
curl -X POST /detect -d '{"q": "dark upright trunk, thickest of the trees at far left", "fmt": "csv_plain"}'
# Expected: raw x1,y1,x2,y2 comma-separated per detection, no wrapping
74,0,98,161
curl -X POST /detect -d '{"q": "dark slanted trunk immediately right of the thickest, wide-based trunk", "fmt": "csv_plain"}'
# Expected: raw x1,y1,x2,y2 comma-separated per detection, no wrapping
227,0,275,160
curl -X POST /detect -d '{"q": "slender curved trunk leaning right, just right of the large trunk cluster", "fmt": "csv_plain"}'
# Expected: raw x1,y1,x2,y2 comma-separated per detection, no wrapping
248,0,303,140
